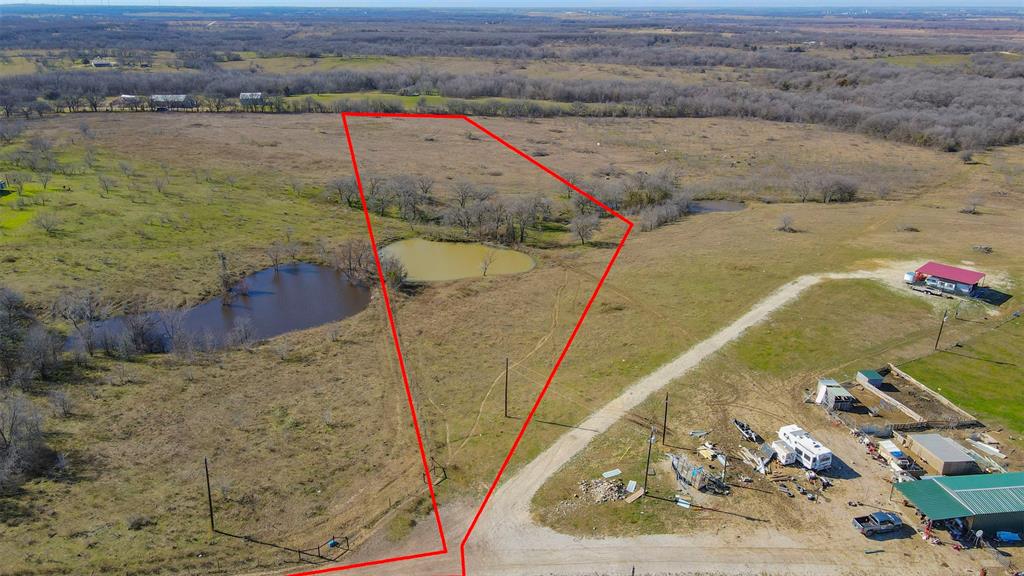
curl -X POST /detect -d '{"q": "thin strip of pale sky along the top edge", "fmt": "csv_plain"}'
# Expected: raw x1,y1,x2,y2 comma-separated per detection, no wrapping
0,0,1024,10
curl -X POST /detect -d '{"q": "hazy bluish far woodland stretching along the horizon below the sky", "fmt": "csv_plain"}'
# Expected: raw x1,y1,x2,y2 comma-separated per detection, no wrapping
0,9,1020,58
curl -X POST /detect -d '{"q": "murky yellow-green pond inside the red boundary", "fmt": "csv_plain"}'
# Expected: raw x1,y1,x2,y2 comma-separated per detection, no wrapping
381,238,536,282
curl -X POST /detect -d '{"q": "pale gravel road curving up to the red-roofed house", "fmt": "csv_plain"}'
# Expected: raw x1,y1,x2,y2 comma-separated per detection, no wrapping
317,262,983,576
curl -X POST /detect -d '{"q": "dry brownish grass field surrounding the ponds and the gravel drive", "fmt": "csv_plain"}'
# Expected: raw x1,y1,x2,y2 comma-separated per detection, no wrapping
0,114,1024,574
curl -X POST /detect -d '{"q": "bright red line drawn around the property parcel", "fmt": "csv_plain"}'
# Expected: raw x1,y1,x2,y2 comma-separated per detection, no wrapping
290,112,633,576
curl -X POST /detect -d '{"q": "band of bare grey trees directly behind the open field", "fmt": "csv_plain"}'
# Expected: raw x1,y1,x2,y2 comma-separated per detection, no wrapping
0,57,1024,151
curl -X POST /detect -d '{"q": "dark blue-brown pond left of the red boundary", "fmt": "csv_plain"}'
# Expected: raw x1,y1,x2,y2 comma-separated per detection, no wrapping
69,262,370,349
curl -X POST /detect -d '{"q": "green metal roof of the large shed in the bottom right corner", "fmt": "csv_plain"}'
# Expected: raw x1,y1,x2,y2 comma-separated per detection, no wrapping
896,472,1024,534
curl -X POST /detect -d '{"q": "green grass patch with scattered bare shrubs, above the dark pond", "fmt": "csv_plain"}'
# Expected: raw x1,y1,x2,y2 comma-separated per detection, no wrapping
0,136,388,304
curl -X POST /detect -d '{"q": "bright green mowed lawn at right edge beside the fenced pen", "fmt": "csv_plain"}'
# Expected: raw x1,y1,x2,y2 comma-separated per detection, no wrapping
901,317,1024,433
